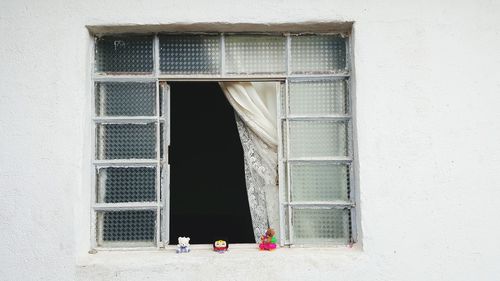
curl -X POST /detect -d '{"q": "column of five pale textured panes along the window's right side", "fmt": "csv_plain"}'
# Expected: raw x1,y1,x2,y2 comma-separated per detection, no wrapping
280,32,354,245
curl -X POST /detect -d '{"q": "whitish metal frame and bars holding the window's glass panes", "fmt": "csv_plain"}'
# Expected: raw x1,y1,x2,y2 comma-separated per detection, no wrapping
91,31,357,250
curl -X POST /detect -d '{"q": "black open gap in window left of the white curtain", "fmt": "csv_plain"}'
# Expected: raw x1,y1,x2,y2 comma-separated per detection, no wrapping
169,82,255,244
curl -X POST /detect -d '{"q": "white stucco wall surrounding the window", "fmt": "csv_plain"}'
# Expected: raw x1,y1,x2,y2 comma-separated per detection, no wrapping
0,0,500,280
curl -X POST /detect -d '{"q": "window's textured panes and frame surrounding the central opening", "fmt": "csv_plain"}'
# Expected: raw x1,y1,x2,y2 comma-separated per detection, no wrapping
92,33,356,248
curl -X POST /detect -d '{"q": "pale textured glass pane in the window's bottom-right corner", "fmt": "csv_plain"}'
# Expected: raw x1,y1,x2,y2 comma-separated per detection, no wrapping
292,208,351,245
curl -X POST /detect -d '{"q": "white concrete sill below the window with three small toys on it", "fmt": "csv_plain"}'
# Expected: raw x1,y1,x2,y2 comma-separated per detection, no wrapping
76,244,366,281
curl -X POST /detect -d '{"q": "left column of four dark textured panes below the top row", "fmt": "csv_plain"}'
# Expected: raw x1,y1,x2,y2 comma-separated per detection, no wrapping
93,75,165,248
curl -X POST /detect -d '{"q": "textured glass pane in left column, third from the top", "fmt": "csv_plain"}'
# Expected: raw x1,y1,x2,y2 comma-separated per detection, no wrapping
96,123,156,159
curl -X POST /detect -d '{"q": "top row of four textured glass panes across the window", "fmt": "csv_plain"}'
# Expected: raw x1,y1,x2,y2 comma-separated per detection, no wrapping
94,33,350,79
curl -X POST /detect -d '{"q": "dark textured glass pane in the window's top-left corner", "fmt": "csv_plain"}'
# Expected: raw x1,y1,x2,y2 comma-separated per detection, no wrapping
95,36,153,74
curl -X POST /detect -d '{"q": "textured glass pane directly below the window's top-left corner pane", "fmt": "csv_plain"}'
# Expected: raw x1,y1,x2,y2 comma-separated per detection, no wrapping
95,82,156,116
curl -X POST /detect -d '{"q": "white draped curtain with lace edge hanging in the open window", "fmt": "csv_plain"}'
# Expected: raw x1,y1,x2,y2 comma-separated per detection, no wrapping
219,82,280,241
